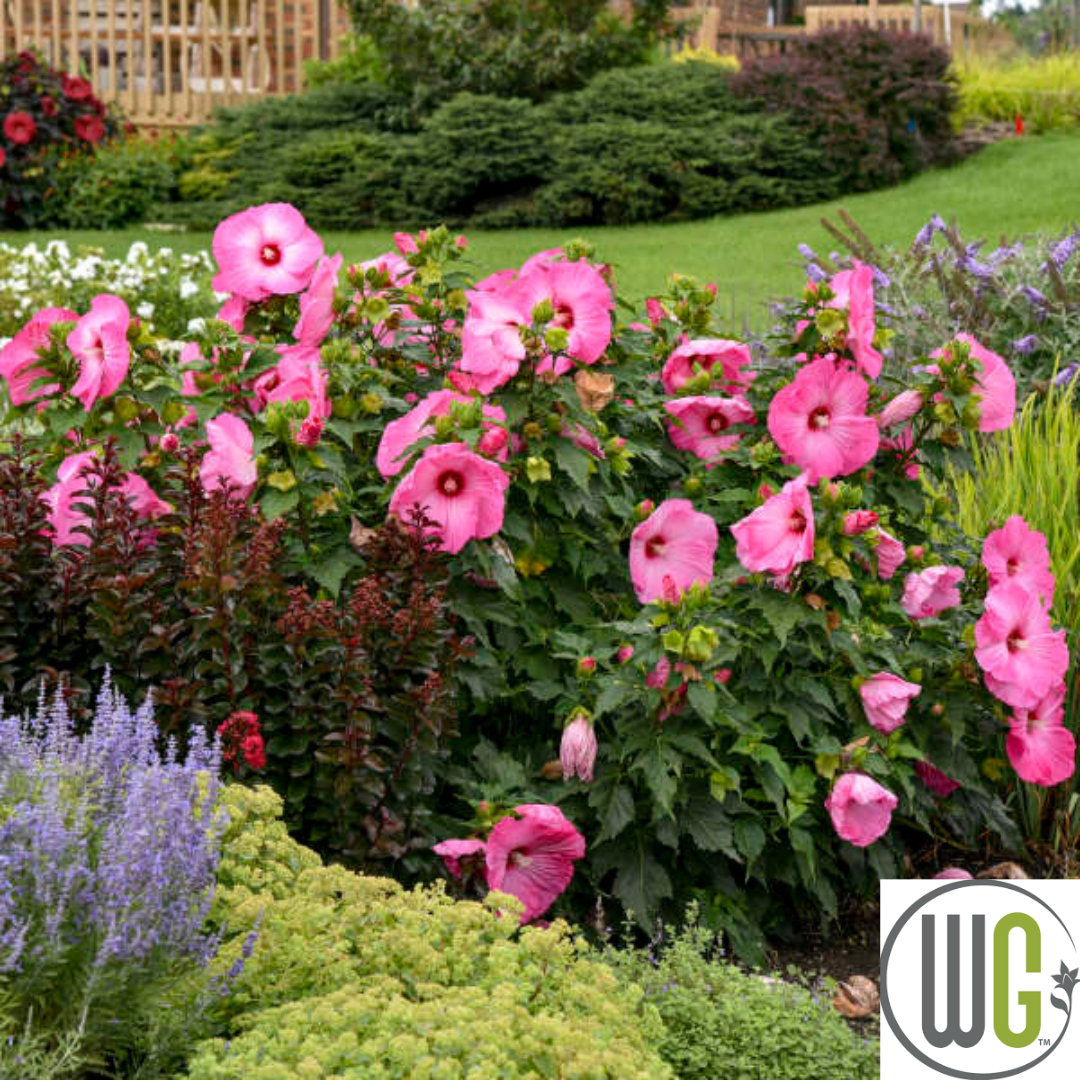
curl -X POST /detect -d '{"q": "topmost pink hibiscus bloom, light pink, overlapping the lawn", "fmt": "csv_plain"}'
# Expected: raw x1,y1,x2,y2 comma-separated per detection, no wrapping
212,203,324,302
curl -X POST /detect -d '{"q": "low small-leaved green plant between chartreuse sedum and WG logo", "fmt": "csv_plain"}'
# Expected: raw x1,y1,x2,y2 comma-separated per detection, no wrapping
606,910,879,1080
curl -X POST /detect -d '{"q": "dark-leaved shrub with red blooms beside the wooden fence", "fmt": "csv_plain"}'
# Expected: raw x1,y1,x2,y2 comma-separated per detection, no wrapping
0,52,120,229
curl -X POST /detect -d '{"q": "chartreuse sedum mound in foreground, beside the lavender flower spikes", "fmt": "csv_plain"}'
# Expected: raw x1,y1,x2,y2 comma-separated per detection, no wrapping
189,786,672,1080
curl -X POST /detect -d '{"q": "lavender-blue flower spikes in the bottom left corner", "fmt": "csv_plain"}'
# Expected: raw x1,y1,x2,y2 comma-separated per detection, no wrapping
0,676,221,996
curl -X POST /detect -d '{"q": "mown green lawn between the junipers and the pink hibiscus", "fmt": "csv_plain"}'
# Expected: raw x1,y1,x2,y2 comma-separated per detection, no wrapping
0,135,1080,322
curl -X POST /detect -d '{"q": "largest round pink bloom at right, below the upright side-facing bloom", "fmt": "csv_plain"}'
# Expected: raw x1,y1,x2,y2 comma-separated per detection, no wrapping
769,356,880,484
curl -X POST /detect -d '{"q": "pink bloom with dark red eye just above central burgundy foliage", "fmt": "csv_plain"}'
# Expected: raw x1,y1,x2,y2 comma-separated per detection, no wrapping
390,443,510,555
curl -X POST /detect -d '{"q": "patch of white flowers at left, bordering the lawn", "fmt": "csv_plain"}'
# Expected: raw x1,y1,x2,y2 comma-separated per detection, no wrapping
0,240,218,346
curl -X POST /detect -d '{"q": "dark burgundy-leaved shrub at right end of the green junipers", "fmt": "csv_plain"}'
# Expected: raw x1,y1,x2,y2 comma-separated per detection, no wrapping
731,27,958,191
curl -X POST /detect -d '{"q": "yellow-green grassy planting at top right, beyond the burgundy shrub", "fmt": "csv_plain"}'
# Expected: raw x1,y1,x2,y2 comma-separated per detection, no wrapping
956,53,1080,134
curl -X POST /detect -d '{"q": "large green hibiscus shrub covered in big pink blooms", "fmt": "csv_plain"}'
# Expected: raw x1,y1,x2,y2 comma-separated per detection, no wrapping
0,204,1075,953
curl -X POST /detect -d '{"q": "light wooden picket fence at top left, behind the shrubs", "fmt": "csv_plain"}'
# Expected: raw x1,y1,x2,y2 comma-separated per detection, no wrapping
0,0,348,127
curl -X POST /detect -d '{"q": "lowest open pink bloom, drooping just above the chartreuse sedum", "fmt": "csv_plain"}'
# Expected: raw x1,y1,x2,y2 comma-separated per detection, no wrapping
485,805,585,922
